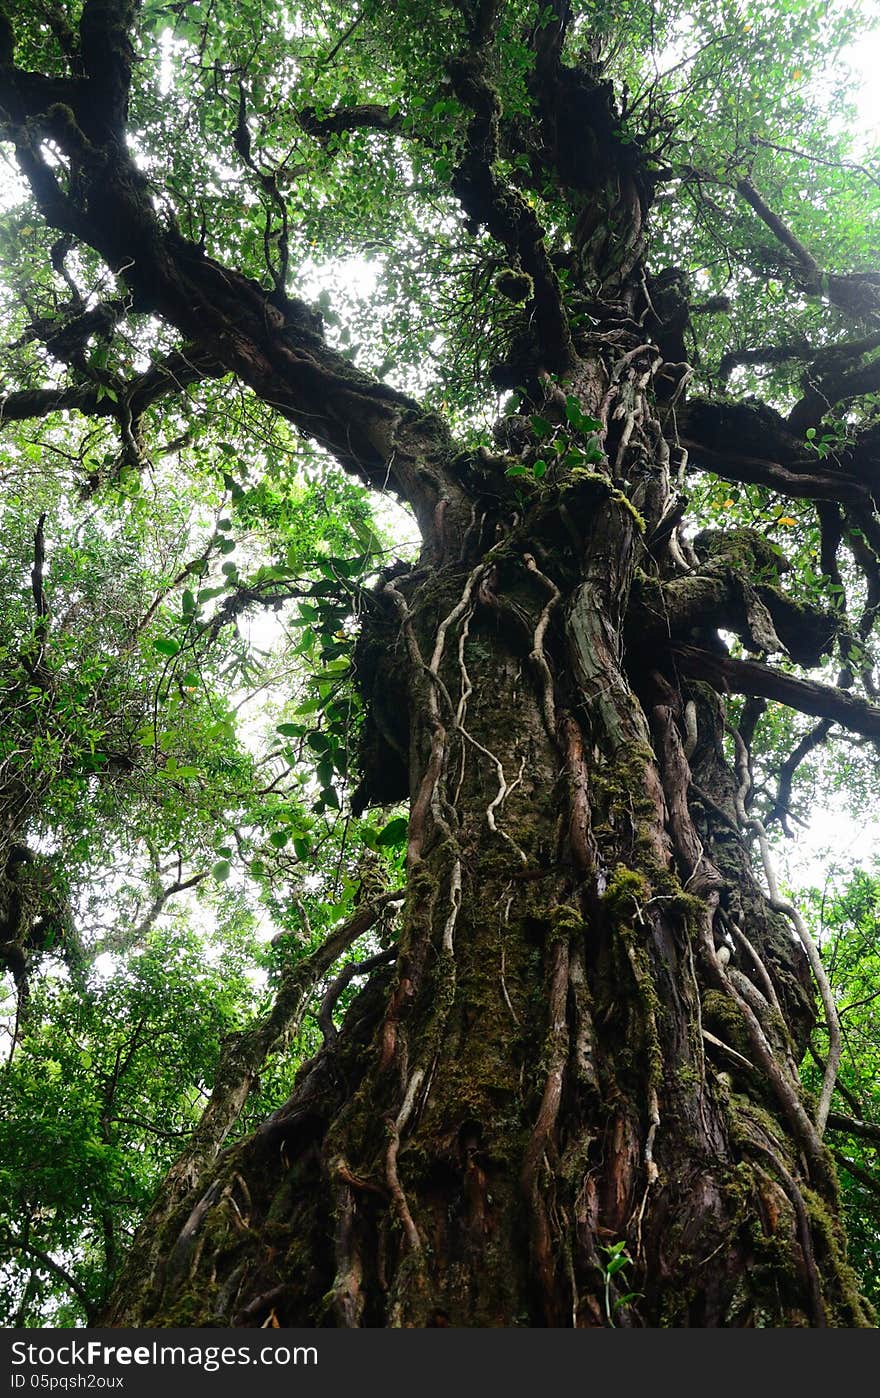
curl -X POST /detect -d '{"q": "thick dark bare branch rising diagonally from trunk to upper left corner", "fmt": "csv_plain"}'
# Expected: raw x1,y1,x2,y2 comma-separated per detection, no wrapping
0,31,450,534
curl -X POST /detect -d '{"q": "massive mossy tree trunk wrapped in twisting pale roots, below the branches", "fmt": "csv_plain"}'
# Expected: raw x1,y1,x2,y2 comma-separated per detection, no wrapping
105,360,865,1327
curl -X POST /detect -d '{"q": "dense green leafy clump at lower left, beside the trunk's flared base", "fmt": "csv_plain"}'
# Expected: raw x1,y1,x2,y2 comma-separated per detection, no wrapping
0,924,255,1325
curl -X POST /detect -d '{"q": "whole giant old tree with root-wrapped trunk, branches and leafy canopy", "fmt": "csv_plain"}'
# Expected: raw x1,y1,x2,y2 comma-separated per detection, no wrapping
0,0,880,1327
